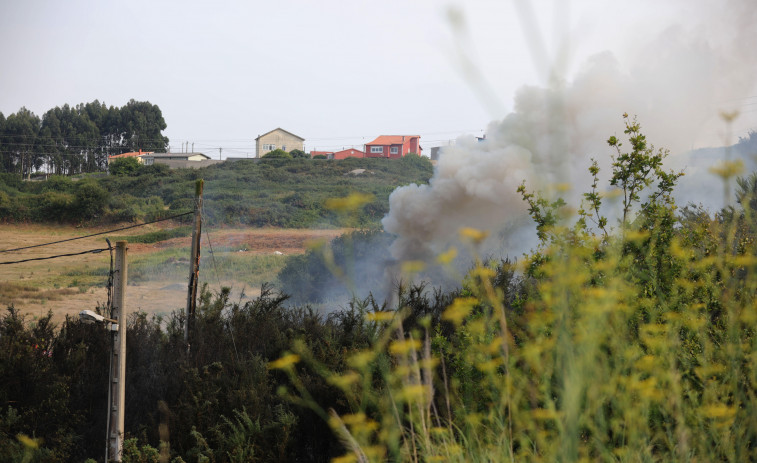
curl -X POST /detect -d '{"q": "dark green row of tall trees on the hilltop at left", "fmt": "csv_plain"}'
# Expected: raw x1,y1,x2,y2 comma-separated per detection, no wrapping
0,99,168,178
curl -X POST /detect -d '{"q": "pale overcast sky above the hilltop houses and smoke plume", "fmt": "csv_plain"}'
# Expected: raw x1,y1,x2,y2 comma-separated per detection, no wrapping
0,0,757,158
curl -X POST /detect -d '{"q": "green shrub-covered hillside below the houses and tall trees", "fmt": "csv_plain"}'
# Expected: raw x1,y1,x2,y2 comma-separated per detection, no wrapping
0,156,433,228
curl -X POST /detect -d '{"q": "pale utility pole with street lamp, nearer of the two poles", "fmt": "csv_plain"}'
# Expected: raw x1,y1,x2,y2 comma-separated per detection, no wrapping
105,241,127,461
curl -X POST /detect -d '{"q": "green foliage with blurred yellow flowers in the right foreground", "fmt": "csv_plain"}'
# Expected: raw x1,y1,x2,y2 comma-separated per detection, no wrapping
272,114,757,461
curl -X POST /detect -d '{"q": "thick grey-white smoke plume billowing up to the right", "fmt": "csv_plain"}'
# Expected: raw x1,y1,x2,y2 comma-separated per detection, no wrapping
382,1,757,260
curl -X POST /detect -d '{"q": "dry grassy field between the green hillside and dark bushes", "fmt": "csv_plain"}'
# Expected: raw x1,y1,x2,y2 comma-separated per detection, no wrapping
0,225,342,320
